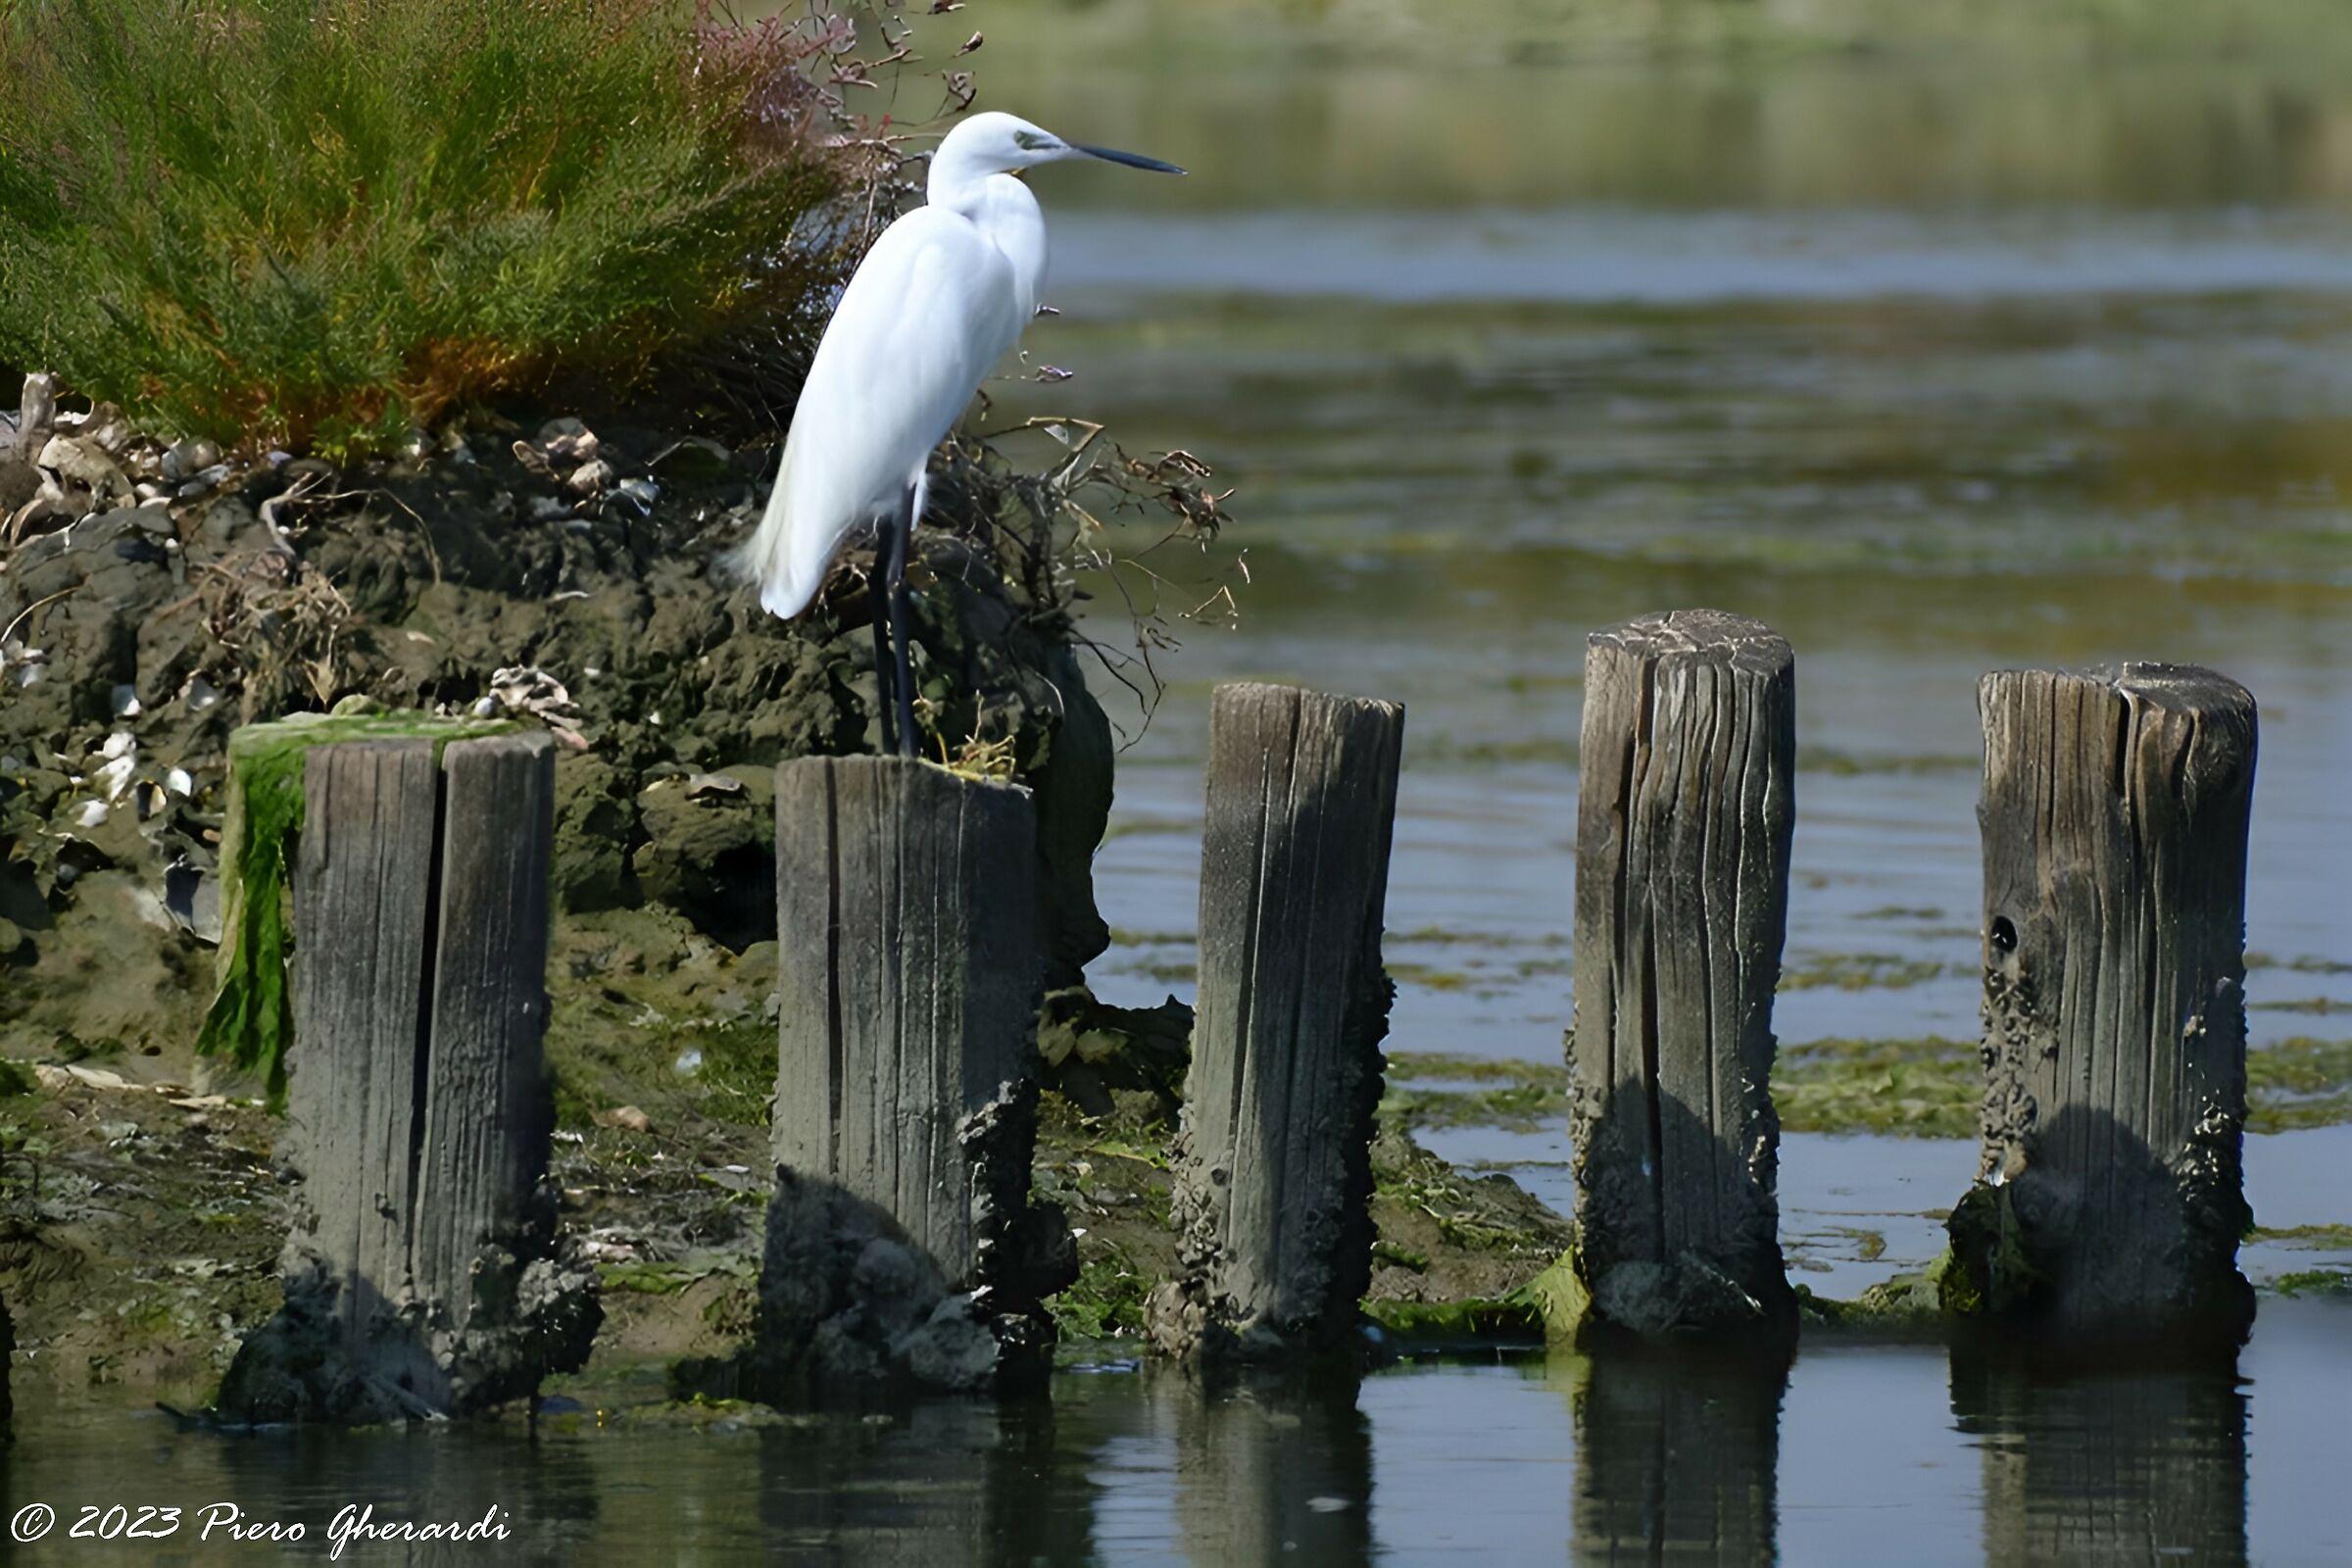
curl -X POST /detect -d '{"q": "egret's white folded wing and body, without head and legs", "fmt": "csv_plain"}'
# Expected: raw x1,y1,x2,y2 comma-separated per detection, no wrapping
743,207,1025,618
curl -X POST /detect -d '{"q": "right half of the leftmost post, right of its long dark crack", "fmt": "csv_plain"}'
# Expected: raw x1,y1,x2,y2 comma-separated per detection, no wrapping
414,731,555,1331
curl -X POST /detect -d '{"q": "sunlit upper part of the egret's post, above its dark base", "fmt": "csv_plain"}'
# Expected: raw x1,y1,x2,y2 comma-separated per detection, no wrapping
771,757,1040,1291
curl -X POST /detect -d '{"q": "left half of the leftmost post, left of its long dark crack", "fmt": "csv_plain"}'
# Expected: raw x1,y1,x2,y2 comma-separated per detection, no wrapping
287,741,440,1348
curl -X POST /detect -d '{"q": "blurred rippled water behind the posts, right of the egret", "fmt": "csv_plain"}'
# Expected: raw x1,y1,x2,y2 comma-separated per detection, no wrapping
945,15,2352,1060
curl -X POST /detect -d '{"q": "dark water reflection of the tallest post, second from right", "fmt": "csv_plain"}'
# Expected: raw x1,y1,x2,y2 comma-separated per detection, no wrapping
1547,1343,1788,1566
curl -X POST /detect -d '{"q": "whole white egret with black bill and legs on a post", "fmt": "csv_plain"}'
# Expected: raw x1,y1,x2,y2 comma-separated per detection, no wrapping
736,113,1183,755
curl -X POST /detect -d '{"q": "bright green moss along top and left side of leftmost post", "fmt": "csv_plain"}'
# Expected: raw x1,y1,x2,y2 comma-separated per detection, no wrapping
195,712,519,1112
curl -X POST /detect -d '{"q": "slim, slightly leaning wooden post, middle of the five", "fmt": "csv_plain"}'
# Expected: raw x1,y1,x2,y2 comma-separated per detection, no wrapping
1148,684,1404,1359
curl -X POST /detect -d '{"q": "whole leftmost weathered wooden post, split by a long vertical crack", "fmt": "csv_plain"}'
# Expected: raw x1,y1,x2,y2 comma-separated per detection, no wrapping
221,733,602,1422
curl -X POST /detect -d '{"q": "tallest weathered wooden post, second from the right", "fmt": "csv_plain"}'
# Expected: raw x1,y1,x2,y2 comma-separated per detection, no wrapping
1569,609,1797,1336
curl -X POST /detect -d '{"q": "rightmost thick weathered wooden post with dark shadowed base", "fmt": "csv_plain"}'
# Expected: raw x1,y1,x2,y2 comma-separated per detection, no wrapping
1952,662,2256,1343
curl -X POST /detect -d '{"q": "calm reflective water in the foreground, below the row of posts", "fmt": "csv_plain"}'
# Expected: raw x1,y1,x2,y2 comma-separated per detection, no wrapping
14,1302,2352,1568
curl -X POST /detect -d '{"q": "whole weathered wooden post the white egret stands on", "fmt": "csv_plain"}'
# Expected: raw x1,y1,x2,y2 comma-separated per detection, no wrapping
758,757,1077,1392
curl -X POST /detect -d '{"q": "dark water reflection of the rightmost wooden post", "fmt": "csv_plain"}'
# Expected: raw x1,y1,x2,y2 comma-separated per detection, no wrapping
1952,1348,2246,1566
